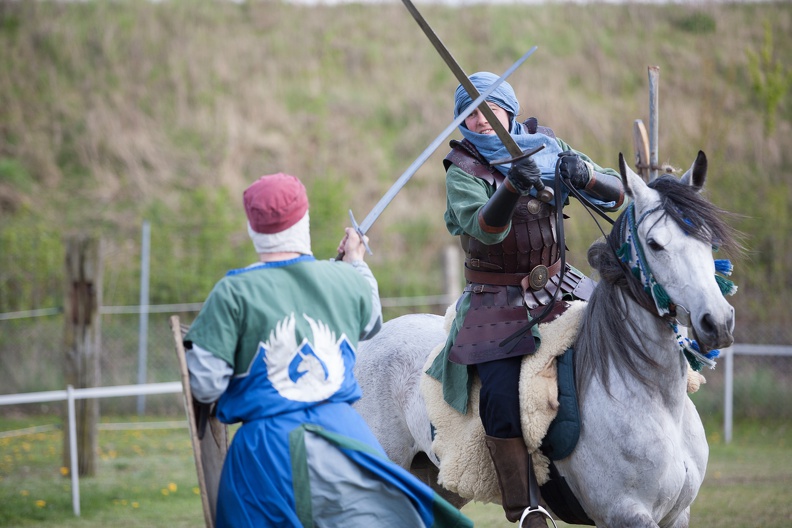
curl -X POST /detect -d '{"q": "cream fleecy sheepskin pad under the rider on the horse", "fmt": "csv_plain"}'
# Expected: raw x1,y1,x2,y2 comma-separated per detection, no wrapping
421,301,586,503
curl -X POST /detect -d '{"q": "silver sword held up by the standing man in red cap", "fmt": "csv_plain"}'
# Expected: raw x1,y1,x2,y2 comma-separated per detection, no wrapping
335,46,536,260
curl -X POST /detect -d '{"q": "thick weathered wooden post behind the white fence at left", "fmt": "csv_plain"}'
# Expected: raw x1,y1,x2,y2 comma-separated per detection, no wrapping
63,235,102,476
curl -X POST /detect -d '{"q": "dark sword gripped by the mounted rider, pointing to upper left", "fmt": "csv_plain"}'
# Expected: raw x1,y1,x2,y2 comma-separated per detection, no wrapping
402,0,553,202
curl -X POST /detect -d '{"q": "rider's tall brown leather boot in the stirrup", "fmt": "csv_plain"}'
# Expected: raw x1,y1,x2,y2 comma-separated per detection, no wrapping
484,436,547,528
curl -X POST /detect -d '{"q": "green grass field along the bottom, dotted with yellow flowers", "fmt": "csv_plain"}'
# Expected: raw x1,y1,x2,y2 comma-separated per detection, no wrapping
0,417,792,528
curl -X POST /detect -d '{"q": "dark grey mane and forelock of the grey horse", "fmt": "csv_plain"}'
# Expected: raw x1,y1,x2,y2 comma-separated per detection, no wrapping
575,175,743,394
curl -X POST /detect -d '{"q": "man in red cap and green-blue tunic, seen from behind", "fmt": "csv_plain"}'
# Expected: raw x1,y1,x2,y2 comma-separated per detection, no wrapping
185,173,472,528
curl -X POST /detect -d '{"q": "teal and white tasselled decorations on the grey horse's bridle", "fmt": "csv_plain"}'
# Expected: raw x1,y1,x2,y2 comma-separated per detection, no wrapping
616,203,737,372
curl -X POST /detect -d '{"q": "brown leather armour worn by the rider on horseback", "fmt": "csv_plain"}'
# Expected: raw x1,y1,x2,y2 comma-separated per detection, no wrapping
444,121,595,365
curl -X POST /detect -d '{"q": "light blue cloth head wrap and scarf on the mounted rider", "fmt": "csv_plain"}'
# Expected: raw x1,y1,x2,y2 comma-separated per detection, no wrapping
454,72,561,185
